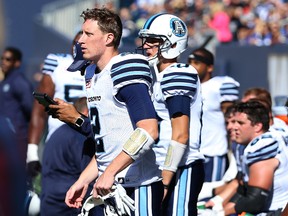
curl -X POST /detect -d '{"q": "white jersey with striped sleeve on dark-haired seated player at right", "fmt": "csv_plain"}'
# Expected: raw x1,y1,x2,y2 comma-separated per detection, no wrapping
242,131,288,211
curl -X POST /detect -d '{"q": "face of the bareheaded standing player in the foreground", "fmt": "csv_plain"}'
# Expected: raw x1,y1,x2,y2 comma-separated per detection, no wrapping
78,19,108,63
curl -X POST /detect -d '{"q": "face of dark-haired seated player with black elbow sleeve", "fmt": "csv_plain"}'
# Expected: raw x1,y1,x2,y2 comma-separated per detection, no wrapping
232,112,255,145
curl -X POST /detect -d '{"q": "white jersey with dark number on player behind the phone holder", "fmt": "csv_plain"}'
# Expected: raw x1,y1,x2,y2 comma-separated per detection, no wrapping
42,54,86,140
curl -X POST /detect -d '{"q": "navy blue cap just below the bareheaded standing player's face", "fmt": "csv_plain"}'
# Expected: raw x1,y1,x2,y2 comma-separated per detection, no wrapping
67,42,89,72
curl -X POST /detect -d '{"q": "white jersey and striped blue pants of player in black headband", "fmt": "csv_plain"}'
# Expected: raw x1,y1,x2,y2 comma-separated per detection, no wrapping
201,76,239,182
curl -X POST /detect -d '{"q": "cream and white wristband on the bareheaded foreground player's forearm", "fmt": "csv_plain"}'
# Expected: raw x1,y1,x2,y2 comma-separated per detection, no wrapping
123,128,155,160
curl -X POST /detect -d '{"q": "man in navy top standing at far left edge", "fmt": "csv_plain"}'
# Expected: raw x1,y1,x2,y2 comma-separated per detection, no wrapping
0,47,33,163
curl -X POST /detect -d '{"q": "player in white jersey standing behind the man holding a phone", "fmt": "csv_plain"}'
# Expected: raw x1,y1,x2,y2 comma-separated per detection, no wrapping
27,32,85,177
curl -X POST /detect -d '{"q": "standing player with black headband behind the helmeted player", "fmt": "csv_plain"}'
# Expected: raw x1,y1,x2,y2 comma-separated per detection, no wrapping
188,48,240,182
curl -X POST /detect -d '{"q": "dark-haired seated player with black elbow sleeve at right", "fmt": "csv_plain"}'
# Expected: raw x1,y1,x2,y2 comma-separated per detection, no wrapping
224,101,288,215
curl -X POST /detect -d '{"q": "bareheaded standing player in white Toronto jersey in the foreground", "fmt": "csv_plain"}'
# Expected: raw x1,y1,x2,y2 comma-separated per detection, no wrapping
56,8,163,215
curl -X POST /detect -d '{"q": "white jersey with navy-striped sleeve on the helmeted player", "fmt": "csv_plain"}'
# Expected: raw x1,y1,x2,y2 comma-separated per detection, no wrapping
152,63,204,166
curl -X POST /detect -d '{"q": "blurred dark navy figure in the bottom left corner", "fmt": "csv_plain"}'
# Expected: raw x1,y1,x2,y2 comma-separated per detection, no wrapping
0,115,26,216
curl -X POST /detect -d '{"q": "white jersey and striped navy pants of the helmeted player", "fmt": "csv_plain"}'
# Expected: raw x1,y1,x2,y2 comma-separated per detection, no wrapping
153,63,204,215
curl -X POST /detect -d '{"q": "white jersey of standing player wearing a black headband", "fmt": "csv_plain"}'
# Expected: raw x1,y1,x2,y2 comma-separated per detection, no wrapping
201,76,240,157
